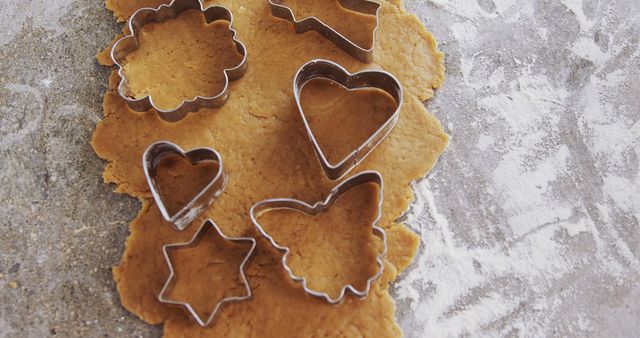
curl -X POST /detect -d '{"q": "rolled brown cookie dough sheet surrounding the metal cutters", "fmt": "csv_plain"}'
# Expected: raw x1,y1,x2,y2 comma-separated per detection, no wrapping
92,0,448,337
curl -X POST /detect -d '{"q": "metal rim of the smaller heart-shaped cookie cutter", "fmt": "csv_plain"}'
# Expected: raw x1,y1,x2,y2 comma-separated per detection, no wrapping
142,141,227,231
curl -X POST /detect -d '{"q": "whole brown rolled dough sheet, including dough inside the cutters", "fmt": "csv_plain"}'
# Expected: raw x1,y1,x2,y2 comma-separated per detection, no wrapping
92,0,448,337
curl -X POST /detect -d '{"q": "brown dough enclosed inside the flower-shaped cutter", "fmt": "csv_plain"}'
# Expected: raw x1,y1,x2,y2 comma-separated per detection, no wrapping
123,10,243,110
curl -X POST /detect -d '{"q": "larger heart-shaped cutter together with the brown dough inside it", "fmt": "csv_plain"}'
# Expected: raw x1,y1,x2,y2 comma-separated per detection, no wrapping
293,59,403,180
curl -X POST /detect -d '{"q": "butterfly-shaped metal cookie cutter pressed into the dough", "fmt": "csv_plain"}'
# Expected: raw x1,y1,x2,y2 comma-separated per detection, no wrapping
250,171,387,304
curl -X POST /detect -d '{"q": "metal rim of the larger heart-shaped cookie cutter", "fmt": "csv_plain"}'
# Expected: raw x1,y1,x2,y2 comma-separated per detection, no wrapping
293,59,404,181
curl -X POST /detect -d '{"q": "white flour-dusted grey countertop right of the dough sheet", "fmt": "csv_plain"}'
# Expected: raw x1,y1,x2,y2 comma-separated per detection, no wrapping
394,0,640,337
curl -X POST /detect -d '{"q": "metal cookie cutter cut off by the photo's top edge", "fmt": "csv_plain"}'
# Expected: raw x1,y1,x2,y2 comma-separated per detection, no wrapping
269,0,381,63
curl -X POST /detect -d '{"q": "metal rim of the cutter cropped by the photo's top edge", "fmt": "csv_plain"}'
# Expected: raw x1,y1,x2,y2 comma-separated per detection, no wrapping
269,0,382,63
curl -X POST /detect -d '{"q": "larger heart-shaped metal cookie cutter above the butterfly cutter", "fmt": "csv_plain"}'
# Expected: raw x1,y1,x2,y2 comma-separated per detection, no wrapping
293,60,403,180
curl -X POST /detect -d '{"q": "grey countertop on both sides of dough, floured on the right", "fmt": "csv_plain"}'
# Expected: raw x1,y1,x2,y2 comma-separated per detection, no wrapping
0,0,640,337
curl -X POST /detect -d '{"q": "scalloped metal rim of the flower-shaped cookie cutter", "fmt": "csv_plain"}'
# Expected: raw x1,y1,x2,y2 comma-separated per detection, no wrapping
109,0,248,122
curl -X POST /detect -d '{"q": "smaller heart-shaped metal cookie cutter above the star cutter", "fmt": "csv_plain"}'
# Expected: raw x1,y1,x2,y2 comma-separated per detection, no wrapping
142,141,227,231
